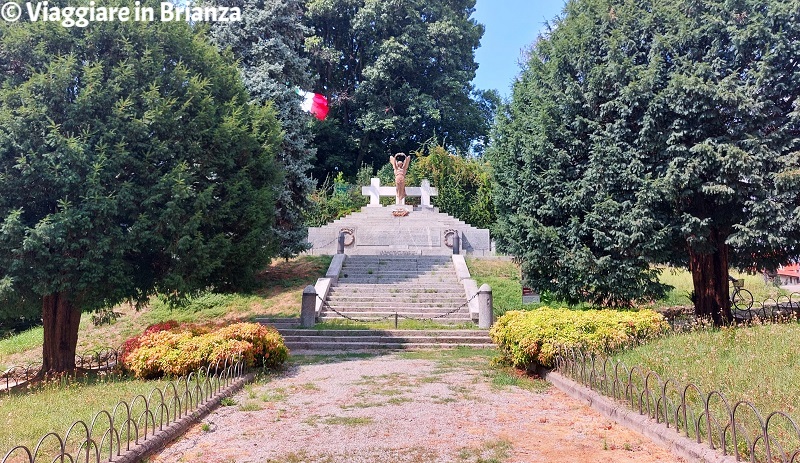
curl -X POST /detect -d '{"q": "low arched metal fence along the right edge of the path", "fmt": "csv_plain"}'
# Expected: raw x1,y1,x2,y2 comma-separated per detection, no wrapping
556,349,800,463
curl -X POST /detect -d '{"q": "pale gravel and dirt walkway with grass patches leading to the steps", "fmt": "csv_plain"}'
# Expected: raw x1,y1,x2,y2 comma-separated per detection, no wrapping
150,350,683,463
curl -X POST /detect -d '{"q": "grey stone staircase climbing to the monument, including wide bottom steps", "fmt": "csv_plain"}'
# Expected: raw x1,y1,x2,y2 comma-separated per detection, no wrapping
257,255,494,353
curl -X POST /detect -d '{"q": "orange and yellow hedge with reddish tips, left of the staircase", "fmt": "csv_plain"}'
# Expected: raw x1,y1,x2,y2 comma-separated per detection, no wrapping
122,322,289,379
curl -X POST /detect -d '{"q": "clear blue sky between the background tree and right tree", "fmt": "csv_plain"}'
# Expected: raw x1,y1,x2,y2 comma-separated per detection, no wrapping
472,0,565,97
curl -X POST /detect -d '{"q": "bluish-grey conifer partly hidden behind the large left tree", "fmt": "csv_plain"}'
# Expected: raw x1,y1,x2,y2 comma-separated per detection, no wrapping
211,0,316,258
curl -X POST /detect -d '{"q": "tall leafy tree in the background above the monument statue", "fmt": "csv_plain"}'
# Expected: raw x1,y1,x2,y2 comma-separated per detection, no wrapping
306,0,493,176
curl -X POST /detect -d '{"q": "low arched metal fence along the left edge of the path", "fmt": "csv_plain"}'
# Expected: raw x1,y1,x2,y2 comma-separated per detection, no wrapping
0,359,244,463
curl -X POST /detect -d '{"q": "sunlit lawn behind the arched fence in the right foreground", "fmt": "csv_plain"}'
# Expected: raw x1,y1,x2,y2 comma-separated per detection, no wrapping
614,323,800,462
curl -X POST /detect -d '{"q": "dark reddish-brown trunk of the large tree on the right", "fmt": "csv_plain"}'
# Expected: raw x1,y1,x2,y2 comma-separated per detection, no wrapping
689,231,732,326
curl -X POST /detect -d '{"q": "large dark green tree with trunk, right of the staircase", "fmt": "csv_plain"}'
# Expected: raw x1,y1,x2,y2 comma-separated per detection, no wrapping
491,0,800,324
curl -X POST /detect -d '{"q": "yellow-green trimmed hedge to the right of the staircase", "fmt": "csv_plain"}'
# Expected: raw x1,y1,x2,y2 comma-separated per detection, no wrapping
489,307,669,368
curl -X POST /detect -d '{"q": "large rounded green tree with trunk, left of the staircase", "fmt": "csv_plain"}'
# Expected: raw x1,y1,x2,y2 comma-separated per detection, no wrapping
0,5,281,372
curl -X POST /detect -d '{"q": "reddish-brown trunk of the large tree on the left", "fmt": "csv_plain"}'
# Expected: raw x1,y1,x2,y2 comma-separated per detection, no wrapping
42,293,81,374
